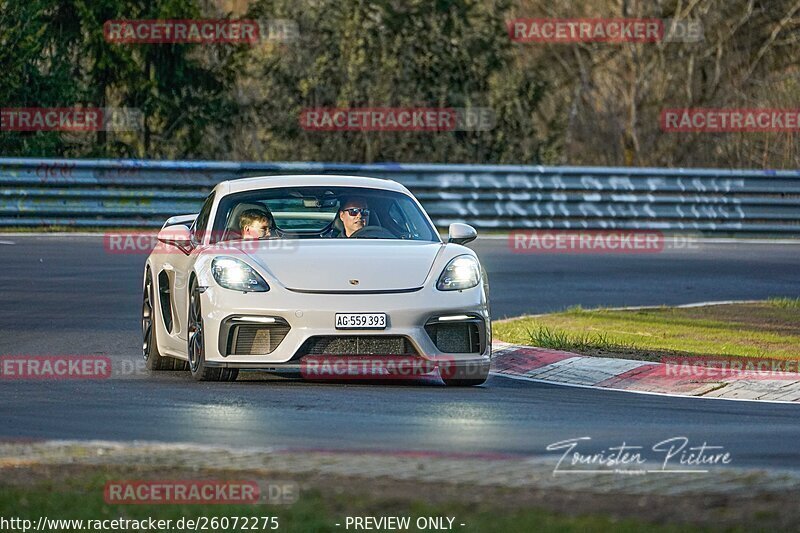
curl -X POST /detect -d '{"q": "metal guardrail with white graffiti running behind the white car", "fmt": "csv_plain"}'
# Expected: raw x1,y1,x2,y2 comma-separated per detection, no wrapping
0,158,800,235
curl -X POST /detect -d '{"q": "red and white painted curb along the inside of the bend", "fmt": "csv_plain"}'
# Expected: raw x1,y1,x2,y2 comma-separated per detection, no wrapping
492,341,800,403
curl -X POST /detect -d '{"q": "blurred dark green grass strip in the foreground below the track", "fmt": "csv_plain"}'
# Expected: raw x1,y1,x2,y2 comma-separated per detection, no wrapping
0,473,698,533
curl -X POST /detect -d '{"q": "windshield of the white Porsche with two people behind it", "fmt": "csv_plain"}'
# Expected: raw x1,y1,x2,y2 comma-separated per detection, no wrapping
212,183,440,242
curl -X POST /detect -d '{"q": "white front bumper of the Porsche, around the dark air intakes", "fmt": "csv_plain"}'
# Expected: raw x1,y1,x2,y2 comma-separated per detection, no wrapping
201,284,491,371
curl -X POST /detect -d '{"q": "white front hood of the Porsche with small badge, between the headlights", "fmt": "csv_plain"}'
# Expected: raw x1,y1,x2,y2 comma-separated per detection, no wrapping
239,239,444,293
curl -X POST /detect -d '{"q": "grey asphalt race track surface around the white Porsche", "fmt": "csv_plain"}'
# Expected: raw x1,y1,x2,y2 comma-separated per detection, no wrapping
0,235,800,470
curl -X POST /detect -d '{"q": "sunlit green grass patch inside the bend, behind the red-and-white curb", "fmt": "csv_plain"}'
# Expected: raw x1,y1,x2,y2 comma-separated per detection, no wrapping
493,298,800,360
